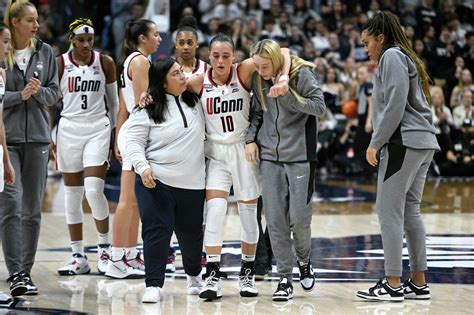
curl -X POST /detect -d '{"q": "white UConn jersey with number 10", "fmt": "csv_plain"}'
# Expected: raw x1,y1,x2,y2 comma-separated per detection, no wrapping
200,65,250,143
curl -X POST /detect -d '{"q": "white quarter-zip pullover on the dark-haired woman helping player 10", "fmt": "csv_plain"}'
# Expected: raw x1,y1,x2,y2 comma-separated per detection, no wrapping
126,94,205,189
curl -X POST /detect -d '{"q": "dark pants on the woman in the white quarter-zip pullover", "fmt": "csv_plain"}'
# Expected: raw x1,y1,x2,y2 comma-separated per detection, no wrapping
135,176,205,287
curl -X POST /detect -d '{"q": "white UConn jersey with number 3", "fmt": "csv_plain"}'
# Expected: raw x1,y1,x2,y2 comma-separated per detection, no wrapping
60,51,107,119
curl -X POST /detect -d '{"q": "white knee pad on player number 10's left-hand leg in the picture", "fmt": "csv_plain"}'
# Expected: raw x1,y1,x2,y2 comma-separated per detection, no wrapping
204,198,227,246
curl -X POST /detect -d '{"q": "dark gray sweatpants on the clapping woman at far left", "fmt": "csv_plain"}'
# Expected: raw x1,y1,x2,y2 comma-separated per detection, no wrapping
0,143,49,276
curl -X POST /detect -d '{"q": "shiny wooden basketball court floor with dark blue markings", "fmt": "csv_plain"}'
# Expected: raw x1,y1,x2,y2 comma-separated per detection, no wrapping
0,177,474,315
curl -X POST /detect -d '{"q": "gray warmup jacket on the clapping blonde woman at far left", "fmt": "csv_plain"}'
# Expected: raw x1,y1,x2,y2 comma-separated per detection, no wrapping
3,39,59,144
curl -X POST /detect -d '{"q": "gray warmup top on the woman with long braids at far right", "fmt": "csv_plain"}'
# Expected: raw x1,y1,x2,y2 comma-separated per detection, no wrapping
370,46,440,150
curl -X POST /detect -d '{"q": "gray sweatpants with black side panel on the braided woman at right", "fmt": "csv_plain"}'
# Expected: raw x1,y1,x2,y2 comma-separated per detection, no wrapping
375,144,434,277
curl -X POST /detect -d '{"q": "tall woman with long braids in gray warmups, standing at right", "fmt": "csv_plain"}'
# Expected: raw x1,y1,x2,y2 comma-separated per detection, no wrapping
357,11,439,301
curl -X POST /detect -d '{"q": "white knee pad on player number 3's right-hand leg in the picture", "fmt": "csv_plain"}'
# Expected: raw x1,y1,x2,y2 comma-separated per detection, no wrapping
84,177,109,221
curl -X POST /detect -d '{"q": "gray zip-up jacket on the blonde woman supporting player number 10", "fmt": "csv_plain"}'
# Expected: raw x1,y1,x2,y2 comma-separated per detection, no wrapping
246,67,326,162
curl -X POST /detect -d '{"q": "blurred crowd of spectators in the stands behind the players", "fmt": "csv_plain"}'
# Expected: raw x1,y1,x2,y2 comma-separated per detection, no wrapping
0,0,474,179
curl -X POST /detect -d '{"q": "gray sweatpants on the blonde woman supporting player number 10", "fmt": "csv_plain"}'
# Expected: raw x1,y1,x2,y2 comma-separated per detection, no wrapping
260,161,315,281
